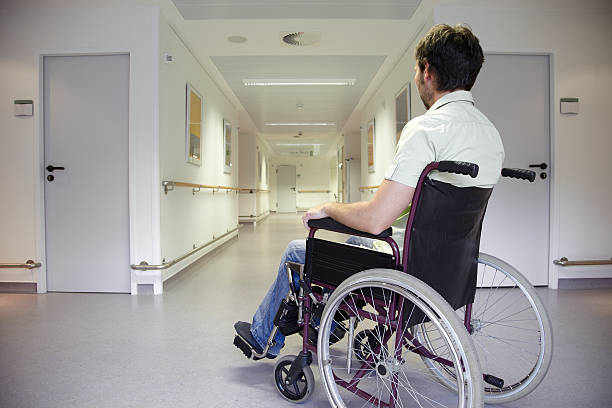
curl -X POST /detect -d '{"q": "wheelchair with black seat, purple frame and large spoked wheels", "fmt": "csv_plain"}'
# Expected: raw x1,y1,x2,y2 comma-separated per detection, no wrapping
234,161,552,407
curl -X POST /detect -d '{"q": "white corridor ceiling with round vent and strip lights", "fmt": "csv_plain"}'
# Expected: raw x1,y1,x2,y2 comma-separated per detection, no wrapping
173,0,421,156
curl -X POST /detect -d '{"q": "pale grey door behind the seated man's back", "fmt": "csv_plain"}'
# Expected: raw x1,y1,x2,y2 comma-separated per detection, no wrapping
472,54,551,285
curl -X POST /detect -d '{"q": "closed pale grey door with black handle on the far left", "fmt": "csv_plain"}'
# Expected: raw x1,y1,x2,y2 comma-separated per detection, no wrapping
43,55,130,292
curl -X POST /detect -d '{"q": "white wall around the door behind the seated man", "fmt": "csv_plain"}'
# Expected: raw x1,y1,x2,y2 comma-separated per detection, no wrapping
436,0,612,282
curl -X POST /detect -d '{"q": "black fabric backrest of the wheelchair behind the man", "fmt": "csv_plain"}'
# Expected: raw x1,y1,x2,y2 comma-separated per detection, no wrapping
404,178,492,309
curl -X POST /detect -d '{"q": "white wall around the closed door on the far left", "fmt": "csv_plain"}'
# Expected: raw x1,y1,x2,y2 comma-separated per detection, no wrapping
0,1,159,291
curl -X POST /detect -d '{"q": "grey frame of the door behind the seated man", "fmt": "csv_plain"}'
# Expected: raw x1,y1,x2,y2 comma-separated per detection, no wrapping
477,48,560,289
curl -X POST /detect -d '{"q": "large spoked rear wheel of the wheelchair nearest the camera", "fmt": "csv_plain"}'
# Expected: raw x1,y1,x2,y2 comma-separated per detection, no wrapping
317,269,483,408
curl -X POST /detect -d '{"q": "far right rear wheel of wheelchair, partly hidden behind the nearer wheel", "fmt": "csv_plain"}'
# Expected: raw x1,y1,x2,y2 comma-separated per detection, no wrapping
414,253,553,404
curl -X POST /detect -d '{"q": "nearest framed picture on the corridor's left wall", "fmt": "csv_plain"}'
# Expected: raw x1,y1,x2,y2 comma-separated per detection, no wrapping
185,83,204,166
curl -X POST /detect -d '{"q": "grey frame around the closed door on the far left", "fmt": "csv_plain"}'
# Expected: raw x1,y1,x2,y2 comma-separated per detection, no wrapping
33,48,134,293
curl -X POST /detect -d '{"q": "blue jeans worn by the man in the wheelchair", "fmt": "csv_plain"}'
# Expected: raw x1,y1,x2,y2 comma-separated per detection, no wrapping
251,237,372,356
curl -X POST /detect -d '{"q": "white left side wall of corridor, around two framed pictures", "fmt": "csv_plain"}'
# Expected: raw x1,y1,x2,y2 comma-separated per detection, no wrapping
158,11,239,276
